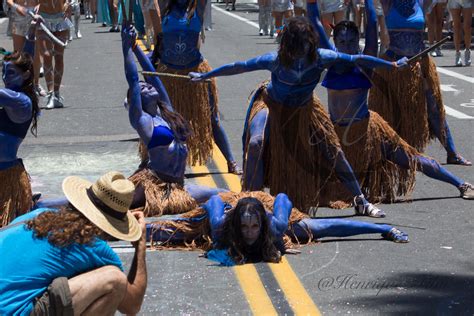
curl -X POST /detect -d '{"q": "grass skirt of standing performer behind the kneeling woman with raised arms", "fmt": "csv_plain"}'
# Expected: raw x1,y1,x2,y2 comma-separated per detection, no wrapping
156,60,218,166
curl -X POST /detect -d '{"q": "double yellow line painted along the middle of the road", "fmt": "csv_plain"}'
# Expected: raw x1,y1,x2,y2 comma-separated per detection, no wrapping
138,40,321,315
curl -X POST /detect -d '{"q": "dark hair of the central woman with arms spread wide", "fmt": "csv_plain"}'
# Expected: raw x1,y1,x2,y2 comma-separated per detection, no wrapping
278,17,319,68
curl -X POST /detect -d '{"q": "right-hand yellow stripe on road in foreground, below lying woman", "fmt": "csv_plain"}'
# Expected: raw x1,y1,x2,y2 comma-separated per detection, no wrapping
268,257,321,315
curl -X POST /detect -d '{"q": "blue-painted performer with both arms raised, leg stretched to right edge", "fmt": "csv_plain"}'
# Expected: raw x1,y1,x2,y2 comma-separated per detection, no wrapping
308,0,474,202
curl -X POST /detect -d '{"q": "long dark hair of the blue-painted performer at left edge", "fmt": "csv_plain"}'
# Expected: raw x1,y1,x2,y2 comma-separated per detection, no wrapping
3,51,40,136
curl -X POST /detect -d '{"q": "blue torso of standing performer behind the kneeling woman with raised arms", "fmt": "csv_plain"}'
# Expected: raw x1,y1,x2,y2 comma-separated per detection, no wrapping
160,10,203,69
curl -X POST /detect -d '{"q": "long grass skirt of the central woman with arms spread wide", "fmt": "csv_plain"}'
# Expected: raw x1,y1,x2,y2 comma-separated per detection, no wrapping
244,85,341,211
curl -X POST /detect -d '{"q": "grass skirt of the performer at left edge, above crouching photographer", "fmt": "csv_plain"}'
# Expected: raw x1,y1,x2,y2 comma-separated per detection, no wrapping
0,162,33,227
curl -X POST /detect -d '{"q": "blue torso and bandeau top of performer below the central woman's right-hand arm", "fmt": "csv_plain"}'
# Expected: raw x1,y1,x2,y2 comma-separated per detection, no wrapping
321,66,372,125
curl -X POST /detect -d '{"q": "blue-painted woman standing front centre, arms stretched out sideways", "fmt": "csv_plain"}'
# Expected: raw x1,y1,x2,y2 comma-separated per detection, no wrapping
189,17,405,217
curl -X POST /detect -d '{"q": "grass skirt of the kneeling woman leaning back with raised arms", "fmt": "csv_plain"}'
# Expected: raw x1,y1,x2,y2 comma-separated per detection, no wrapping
129,168,198,217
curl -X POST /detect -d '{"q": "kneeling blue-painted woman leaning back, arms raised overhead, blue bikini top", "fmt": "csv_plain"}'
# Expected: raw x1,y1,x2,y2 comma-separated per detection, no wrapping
122,25,225,216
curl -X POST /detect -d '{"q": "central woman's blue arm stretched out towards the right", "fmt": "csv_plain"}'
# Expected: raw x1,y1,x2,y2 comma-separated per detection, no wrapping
318,49,408,69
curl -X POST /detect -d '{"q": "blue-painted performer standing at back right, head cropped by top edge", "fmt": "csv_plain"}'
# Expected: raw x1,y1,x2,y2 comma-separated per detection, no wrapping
369,0,472,166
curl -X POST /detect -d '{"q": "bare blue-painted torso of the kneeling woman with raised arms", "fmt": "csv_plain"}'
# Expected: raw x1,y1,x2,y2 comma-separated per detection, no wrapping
148,117,188,182
